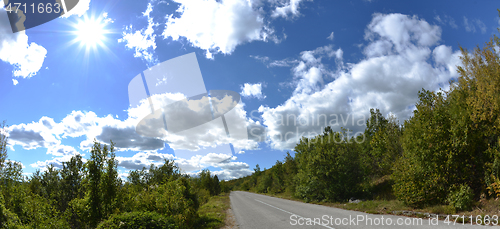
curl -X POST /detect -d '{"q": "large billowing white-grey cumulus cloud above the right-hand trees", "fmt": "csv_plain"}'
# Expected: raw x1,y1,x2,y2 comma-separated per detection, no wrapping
259,14,460,149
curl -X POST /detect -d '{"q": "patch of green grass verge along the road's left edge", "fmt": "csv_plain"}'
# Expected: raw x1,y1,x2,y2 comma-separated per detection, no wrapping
196,193,231,229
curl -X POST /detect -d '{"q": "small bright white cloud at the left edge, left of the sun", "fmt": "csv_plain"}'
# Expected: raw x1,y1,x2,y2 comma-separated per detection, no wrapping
0,8,47,79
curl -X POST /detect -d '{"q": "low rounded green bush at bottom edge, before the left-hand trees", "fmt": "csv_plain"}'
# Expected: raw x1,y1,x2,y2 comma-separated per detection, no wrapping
97,212,179,229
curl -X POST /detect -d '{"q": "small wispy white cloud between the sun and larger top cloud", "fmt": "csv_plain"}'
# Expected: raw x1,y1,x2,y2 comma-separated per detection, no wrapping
118,3,158,63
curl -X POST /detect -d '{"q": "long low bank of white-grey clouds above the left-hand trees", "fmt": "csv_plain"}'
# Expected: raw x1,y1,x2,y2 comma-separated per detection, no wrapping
12,96,262,178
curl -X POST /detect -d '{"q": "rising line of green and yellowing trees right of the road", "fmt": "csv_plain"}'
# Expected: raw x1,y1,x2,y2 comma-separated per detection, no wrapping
230,21,500,210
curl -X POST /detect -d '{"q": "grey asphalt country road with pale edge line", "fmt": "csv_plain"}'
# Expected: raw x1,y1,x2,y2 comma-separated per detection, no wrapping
230,191,488,229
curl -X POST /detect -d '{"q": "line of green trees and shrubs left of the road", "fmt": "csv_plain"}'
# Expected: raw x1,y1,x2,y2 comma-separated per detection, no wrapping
0,135,227,228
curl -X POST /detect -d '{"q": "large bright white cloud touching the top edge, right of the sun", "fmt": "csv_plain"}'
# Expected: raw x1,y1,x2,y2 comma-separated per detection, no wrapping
163,0,274,58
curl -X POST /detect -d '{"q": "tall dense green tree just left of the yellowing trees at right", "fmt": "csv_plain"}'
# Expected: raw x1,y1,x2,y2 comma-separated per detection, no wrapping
393,90,451,206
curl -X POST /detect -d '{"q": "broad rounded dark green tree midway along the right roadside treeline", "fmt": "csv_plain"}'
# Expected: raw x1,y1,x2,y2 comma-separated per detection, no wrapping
295,130,364,201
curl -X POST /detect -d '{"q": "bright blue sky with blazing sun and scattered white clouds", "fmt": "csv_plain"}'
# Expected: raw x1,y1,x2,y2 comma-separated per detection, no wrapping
0,0,500,180
